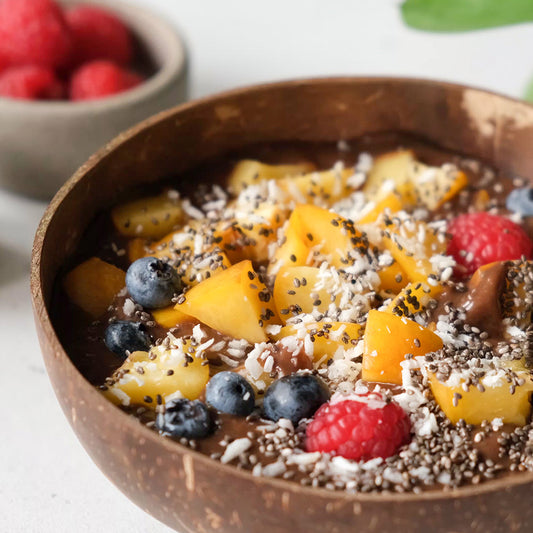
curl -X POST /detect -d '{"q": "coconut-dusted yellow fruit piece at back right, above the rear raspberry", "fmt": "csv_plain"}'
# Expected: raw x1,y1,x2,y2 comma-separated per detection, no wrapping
408,161,468,211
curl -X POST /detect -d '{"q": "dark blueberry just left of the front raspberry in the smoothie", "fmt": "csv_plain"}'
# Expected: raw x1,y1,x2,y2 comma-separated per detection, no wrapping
263,374,330,425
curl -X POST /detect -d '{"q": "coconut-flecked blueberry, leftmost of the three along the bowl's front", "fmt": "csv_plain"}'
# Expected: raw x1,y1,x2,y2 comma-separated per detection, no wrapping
155,398,215,439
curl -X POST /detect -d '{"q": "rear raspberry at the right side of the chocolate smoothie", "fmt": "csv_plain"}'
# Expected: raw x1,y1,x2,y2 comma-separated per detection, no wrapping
448,213,533,277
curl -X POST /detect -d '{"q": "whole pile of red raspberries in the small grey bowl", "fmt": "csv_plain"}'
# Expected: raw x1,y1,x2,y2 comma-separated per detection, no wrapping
0,0,143,101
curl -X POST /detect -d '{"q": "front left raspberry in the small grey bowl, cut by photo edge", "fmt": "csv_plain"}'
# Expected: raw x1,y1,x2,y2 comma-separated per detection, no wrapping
0,65,64,100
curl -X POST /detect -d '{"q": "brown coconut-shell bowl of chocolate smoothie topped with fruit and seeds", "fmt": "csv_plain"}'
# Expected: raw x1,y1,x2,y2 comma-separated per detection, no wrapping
32,78,533,532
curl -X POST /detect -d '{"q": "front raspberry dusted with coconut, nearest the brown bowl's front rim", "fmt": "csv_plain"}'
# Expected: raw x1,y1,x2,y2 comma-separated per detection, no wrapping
305,393,411,461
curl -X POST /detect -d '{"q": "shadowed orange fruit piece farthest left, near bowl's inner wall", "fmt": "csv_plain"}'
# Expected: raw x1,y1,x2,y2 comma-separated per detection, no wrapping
63,257,126,318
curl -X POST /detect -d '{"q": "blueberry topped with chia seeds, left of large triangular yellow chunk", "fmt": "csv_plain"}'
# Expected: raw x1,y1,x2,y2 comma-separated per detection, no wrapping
126,257,181,309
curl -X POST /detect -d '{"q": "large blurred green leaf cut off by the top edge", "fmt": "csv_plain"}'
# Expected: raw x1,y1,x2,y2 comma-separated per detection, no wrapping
401,0,533,32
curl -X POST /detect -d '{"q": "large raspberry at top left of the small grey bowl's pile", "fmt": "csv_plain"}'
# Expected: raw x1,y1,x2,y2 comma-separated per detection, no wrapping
0,0,72,68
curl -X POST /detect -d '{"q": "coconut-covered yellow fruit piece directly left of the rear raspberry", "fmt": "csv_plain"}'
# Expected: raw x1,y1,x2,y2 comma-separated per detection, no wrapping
383,217,446,284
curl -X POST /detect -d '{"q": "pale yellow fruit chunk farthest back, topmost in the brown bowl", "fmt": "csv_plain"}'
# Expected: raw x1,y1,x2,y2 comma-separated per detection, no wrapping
363,150,415,205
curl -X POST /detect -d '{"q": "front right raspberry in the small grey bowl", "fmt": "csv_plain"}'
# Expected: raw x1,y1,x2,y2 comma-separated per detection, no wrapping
70,61,143,100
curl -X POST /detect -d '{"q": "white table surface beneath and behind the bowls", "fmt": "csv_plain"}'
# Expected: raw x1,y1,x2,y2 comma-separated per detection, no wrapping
0,0,533,533
